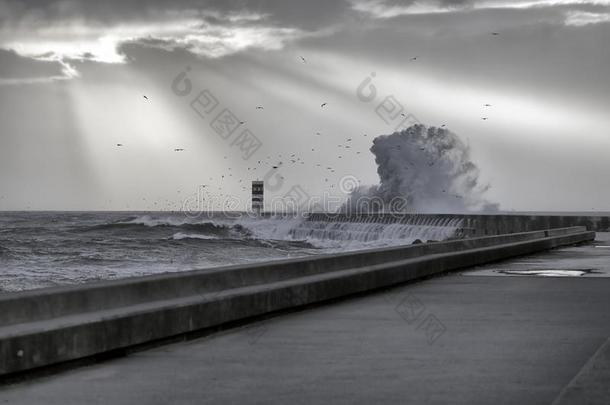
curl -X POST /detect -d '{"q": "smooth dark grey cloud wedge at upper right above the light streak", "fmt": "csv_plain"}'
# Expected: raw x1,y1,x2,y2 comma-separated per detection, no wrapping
298,3,610,108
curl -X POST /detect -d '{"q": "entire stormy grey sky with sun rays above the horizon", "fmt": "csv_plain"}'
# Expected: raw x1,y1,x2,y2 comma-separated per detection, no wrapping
0,0,610,211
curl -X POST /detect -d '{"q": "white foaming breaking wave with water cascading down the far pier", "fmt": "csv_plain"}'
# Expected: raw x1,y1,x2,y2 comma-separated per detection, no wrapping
96,214,462,248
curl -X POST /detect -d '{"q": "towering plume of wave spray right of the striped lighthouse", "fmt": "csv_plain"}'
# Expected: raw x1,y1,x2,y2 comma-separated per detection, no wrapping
342,124,499,213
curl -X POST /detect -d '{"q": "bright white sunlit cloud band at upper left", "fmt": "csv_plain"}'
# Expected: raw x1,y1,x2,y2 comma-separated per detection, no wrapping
0,10,319,80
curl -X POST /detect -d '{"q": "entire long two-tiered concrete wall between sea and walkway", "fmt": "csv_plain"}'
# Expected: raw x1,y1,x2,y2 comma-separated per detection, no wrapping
0,227,594,375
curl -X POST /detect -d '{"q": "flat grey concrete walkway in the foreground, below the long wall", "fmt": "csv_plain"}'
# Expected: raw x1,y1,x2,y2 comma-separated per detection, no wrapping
0,232,610,405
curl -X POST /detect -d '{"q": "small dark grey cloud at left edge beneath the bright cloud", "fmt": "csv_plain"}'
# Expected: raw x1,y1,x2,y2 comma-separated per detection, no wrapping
0,49,64,83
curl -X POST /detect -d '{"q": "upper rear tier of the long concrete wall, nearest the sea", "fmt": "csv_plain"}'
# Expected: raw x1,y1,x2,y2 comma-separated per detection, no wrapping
0,229,552,325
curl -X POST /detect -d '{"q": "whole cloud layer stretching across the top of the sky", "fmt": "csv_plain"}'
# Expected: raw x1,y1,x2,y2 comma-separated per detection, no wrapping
0,0,610,99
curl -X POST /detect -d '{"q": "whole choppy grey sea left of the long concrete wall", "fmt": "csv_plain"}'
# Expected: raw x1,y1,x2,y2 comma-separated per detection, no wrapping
0,212,460,291
